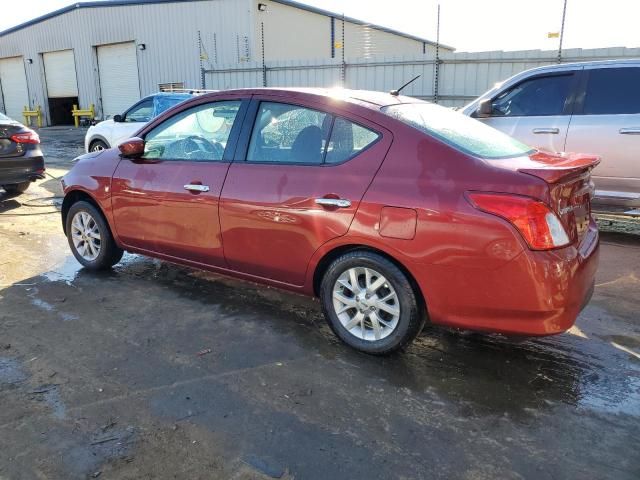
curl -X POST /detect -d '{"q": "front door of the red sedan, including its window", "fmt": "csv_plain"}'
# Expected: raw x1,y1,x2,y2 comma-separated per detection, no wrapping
111,98,248,266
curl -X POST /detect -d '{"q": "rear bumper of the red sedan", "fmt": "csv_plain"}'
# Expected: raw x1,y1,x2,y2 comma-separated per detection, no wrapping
415,220,599,336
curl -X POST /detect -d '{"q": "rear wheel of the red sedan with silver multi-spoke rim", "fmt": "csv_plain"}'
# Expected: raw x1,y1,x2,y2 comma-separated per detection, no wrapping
320,251,425,355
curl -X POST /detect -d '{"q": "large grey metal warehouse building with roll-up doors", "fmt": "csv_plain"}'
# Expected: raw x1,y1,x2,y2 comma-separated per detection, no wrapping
0,0,453,125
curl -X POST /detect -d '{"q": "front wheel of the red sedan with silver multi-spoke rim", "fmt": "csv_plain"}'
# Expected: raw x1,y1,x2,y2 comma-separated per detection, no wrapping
66,201,124,270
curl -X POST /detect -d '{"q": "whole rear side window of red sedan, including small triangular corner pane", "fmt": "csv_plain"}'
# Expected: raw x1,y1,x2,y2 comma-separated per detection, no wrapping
247,102,379,165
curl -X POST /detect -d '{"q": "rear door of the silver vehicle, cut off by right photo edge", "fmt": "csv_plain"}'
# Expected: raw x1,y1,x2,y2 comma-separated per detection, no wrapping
566,64,640,201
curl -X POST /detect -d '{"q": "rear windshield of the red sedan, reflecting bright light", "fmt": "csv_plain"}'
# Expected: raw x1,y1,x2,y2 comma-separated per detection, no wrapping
382,103,533,159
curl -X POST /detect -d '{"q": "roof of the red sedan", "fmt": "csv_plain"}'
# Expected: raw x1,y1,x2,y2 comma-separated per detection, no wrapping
198,88,424,110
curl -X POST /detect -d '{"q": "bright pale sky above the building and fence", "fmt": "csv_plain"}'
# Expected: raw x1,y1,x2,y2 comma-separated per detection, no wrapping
0,0,640,51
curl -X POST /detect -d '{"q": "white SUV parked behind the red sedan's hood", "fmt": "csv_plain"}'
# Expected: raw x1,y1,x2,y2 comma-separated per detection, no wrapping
84,92,193,152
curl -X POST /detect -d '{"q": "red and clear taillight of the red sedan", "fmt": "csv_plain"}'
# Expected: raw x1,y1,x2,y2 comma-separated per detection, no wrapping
467,192,569,250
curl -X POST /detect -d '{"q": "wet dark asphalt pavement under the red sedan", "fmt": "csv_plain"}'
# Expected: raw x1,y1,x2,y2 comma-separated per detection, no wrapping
0,129,640,480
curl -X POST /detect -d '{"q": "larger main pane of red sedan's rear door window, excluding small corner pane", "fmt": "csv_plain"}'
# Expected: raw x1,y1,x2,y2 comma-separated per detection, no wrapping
247,102,331,164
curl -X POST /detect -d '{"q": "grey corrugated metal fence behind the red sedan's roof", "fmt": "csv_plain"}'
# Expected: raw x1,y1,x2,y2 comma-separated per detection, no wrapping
206,48,640,106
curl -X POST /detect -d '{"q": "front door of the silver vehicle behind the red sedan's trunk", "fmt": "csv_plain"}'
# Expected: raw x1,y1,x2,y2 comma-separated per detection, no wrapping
478,70,579,152
